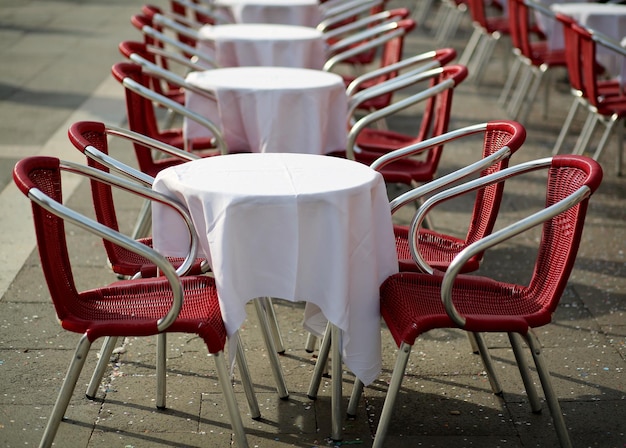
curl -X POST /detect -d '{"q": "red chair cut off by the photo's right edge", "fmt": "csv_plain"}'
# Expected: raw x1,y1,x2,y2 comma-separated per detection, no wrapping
553,14,626,175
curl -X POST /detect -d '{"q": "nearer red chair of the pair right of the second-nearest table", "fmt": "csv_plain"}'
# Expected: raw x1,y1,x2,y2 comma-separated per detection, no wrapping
346,65,467,191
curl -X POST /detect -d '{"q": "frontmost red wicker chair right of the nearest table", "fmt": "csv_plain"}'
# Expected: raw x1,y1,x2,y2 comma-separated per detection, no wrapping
353,156,602,448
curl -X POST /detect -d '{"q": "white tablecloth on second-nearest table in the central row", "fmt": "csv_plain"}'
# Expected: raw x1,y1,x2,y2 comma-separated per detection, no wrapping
184,67,348,154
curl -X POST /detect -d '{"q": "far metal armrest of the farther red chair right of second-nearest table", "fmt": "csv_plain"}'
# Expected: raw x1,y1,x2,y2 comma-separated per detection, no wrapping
346,48,456,96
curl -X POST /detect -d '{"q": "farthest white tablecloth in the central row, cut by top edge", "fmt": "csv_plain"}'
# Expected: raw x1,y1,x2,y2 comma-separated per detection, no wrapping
213,0,322,28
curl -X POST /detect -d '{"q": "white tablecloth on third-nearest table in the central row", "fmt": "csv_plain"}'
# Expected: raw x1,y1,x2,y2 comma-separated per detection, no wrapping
196,24,327,70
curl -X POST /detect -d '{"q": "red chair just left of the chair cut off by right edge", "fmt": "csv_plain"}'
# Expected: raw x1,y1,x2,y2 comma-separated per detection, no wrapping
498,0,566,122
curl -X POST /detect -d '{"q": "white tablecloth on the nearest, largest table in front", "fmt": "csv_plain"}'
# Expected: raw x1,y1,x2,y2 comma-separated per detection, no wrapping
153,154,398,384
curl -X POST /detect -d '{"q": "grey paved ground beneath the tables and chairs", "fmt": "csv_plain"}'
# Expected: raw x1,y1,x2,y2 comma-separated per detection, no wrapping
0,0,626,448
